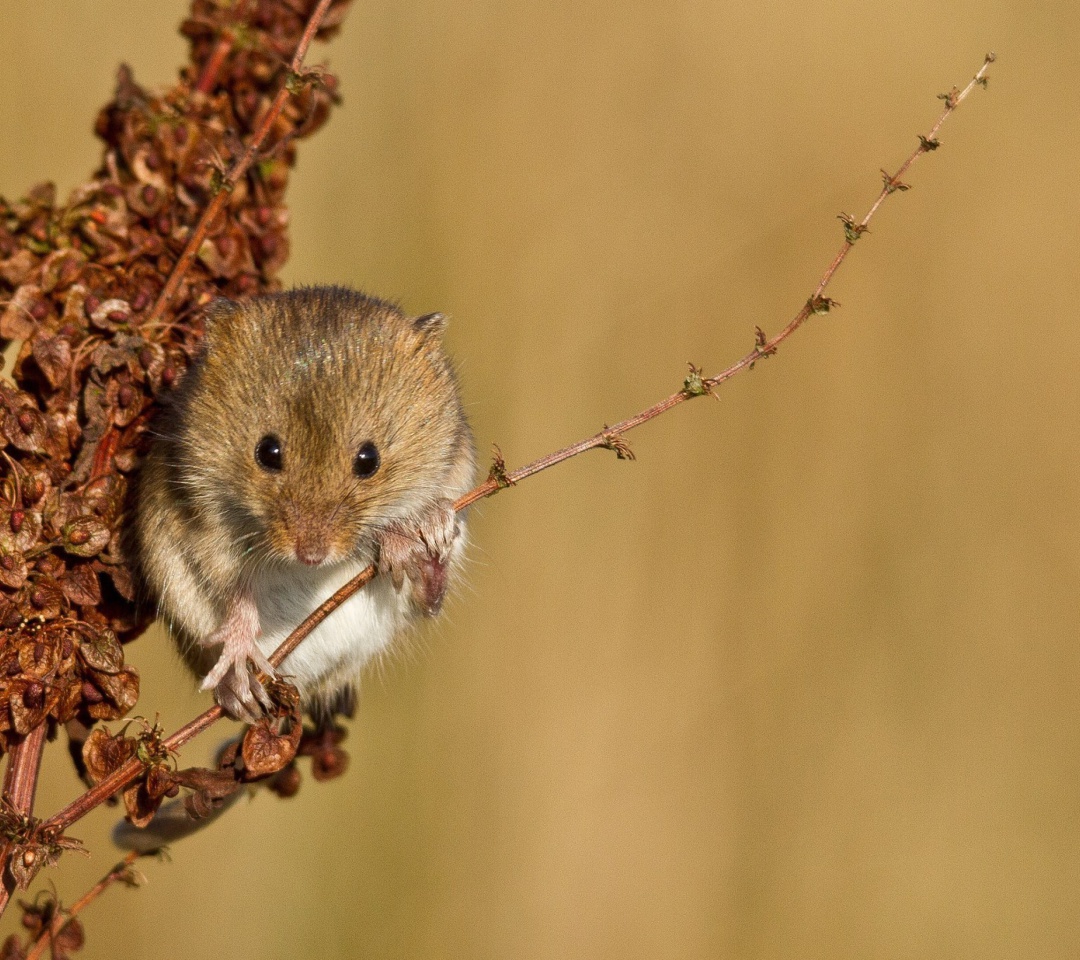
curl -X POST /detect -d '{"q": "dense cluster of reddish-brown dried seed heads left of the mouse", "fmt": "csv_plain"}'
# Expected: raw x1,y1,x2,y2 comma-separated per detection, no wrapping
0,0,346,753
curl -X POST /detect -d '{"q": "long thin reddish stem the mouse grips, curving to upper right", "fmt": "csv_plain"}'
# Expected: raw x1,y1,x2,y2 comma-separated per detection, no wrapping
46,56,994,829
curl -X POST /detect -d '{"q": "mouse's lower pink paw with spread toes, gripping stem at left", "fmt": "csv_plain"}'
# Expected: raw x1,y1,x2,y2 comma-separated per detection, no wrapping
200,598,275,724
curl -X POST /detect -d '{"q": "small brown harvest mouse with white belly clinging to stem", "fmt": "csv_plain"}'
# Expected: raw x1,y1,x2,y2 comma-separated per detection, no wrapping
135,287,475,719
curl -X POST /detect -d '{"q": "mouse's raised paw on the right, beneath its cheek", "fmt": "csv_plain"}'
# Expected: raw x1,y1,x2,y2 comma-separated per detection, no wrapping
379,500,461,617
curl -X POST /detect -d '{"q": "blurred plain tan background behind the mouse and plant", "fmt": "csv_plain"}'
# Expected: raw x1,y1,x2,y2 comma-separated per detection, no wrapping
0,0,1080,960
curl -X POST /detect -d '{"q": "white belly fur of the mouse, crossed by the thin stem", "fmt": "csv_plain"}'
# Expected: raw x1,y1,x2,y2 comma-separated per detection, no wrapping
252,563,409,694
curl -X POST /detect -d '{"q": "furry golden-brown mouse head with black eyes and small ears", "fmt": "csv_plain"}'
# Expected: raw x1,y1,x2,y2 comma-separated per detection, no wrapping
172,287,472,566
